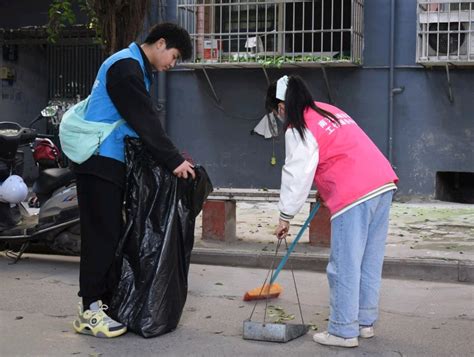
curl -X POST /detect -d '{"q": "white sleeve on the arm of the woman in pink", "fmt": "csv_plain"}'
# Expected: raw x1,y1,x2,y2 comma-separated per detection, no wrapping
278,129,319,221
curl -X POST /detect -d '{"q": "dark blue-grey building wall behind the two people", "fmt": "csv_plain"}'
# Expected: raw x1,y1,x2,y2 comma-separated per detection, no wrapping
164,0,474,196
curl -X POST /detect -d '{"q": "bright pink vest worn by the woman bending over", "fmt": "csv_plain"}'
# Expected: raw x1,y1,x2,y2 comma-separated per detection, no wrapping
304,102,398,214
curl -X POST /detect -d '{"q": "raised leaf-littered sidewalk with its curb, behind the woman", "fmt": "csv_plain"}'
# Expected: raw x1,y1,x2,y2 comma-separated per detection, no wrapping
193,200,474,283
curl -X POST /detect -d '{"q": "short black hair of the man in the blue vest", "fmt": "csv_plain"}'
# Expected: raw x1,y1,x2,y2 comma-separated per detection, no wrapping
145,22,193,60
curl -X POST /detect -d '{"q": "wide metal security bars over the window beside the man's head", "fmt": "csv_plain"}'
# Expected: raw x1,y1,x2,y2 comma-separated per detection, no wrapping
177,0,364,68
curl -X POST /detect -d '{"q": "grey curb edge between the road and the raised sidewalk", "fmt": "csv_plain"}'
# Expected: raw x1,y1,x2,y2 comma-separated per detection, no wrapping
191,248,474,283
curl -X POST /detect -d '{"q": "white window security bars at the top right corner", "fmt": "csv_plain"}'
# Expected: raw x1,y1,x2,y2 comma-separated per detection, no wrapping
416,0,474,66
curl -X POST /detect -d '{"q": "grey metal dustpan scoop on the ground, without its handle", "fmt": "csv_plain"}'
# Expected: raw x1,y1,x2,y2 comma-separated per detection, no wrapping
243,320,309,342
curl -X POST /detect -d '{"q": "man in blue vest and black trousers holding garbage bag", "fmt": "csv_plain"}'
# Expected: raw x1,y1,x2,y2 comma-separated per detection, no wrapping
73,23,195,337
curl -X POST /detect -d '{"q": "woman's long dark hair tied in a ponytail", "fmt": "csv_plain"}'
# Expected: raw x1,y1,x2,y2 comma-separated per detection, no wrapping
265,76,339,140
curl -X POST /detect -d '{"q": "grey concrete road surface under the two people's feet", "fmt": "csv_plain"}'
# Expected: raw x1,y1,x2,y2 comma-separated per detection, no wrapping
0,254,474,357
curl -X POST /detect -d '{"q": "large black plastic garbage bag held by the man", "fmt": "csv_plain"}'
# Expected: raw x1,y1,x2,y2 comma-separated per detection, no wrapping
110,138,213,337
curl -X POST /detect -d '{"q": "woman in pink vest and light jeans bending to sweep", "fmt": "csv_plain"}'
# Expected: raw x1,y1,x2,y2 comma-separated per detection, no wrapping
266,76,398,347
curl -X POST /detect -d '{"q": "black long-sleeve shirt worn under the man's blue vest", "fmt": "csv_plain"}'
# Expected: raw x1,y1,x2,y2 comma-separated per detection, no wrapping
74,44,184,186
